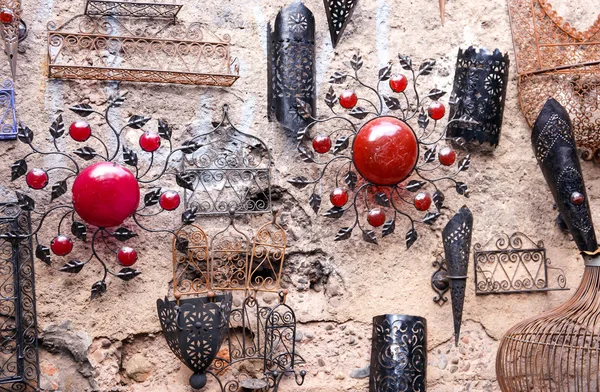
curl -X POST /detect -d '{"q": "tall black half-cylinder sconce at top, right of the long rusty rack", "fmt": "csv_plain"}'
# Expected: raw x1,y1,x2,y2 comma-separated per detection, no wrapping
267,1,317,134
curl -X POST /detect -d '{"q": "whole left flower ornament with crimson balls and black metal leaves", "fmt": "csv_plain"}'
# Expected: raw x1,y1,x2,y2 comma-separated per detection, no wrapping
5,94,207,298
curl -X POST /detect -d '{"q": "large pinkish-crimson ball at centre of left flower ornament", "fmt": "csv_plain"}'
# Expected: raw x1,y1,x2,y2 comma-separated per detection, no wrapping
73,162,140,227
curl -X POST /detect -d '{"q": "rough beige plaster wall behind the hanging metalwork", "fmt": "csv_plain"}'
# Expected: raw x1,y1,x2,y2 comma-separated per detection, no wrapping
0,0,600,392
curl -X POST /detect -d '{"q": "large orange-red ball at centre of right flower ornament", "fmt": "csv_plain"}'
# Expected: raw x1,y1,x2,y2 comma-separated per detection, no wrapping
352,116,419,185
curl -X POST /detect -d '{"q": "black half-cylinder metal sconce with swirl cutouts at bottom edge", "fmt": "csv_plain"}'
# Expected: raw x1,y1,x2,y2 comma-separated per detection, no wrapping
369,314,427,392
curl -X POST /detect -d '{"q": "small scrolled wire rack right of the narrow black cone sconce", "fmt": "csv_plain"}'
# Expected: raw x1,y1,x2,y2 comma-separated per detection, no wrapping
473,232,569,295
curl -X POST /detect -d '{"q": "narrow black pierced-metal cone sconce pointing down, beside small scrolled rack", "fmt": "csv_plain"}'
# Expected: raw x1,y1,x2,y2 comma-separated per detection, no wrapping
431,206,473,345
